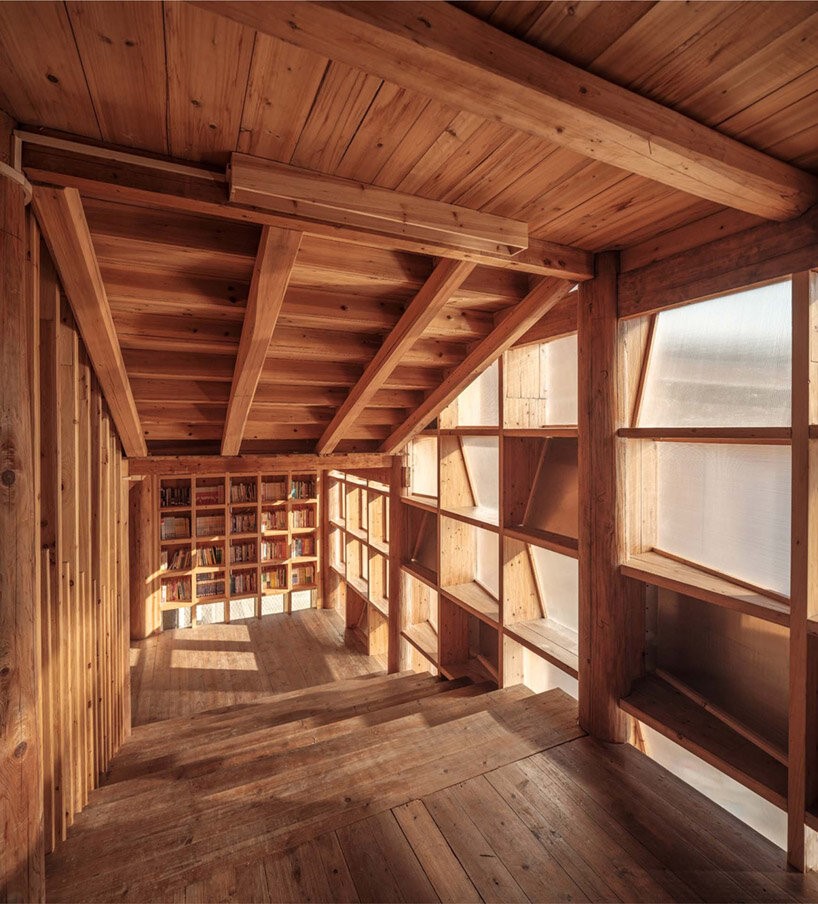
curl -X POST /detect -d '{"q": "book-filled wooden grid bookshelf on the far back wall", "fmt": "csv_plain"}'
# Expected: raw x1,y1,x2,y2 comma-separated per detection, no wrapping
157,471,321,626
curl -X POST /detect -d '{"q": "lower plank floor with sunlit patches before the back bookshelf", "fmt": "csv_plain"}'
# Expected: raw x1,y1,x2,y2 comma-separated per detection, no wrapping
131,609,385,725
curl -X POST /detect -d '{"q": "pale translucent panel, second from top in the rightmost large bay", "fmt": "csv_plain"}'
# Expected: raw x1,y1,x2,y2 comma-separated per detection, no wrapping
656,443,790,594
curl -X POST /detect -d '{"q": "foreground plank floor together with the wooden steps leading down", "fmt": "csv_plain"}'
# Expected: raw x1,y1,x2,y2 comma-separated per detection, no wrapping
47,644,818,902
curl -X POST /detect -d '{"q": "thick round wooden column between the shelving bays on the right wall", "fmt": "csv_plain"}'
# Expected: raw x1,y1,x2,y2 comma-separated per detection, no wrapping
577,252,644,742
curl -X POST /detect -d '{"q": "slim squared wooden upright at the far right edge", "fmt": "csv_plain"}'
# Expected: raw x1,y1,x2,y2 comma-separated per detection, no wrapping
787,272,818,871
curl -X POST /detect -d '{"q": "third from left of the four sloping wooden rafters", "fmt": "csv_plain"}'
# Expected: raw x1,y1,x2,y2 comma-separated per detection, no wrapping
317,260,474,455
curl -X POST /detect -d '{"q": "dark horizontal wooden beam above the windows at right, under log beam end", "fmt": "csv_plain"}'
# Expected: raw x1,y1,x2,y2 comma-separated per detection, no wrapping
619,206,818,317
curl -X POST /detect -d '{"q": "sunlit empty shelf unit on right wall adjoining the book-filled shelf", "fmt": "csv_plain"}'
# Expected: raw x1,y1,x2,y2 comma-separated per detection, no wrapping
327,471,390,658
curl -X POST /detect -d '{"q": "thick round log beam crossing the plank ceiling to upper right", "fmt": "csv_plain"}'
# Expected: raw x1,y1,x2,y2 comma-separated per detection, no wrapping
202,0,818,220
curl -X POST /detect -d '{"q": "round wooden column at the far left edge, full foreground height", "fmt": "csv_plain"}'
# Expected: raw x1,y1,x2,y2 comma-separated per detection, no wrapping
0,164,45,901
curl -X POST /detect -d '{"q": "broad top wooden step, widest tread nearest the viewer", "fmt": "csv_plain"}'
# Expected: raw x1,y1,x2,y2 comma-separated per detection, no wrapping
49,689,582,900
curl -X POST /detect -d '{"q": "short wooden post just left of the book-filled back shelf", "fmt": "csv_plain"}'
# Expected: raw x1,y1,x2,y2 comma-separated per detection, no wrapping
129,477,160,640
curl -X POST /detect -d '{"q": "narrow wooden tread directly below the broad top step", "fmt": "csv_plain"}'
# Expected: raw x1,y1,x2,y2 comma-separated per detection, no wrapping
101,679,493,799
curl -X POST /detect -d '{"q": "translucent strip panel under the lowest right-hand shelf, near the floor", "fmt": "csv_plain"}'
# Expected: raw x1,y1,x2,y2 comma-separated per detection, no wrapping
640,723,787,848
